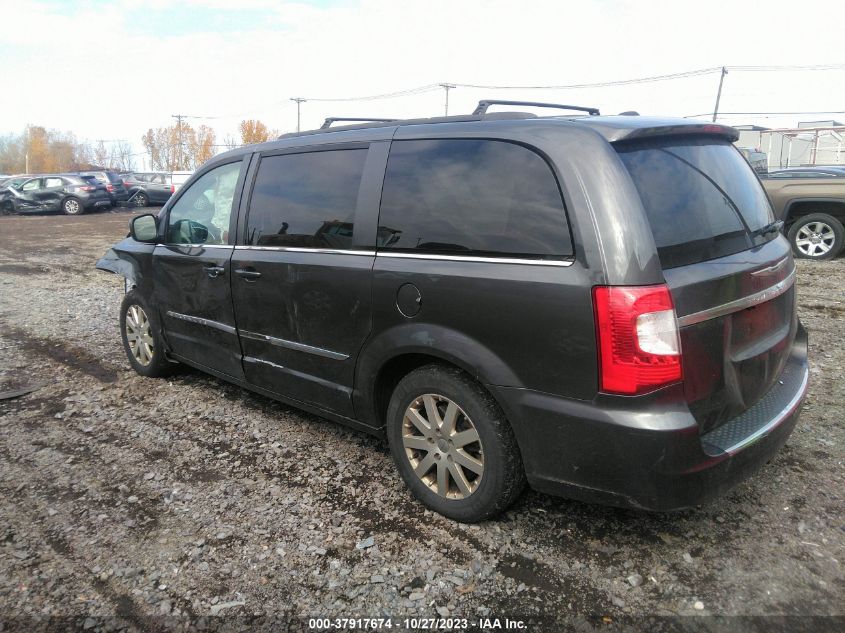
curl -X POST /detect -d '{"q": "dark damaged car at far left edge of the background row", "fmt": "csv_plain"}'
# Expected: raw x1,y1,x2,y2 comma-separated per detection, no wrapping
0,174,111,215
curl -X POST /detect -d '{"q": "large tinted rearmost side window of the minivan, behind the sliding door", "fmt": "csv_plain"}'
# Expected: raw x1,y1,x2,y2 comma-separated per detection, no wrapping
377,139,572,259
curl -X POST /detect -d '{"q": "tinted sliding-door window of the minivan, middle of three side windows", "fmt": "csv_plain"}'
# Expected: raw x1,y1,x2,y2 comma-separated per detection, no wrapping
246,149,367,249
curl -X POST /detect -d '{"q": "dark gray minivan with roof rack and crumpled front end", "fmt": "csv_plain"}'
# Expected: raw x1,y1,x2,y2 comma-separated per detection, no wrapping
97,102,808,521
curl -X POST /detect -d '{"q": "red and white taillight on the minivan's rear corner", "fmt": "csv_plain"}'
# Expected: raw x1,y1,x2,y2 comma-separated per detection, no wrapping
593,285,683,396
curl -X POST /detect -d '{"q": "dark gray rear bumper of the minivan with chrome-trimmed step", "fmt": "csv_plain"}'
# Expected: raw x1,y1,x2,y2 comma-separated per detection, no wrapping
492,325,808,511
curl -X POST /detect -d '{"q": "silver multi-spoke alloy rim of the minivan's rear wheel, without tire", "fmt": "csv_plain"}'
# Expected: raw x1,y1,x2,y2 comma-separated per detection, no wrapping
402,393,484,499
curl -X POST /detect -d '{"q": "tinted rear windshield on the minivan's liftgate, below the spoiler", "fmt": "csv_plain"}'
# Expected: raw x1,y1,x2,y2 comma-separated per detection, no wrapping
616,138,777,269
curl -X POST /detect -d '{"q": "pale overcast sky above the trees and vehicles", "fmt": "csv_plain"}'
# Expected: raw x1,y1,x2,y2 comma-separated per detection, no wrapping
0,0,845,167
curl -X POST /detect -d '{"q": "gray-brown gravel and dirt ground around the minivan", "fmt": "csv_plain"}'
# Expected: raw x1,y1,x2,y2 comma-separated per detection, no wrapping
0,211,845,631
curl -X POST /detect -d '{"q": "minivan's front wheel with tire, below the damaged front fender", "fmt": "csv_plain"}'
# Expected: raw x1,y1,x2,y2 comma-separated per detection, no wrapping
120,290,173,378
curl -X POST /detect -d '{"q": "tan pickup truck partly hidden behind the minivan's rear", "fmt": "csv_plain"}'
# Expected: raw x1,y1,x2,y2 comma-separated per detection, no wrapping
761,167,845,259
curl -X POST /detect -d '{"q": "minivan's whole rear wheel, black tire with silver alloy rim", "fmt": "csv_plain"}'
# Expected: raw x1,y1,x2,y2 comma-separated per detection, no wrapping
387,365,525,523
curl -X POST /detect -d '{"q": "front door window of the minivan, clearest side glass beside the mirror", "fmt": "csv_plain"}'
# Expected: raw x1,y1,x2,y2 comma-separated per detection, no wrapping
165,161,241,244
